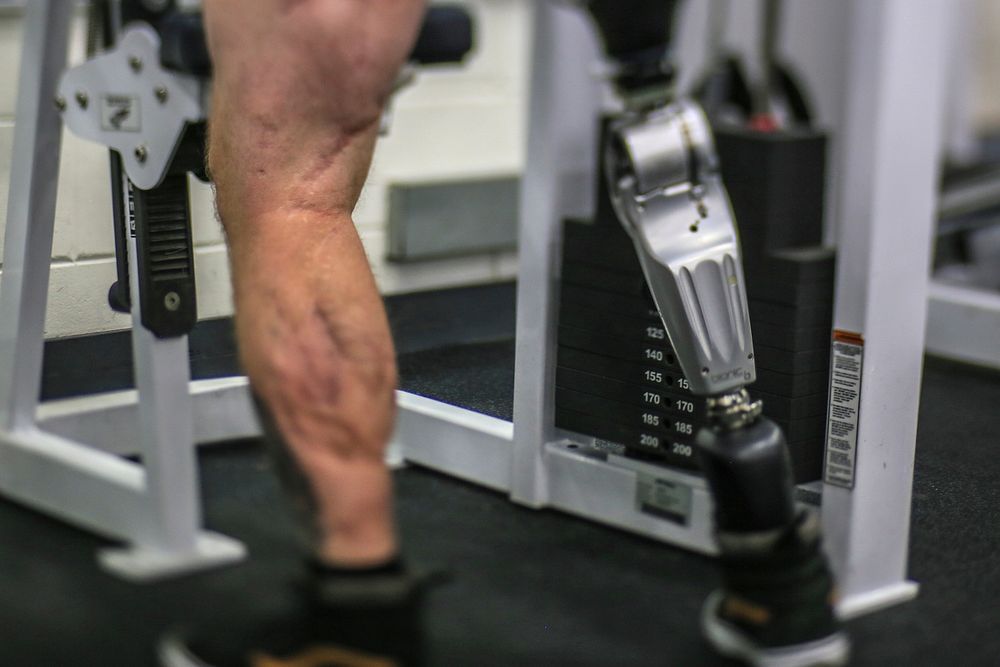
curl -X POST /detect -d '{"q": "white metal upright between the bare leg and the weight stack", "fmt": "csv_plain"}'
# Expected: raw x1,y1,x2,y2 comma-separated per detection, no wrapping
511,2,600,507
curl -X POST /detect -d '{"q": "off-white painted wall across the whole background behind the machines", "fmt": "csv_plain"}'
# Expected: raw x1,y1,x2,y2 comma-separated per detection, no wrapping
0,0,1000,336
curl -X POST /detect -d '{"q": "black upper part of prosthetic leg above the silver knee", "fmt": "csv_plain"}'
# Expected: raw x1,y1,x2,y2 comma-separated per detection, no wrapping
587,0,679,91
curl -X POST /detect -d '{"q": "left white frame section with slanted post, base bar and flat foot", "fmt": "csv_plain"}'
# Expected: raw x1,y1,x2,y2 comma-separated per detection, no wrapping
0,0,244,579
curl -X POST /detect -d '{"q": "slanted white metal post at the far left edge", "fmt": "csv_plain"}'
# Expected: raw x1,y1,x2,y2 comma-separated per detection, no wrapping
0,0,73,431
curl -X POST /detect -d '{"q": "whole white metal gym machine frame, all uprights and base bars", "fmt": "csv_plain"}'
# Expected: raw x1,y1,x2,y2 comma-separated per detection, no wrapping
0,0,947,616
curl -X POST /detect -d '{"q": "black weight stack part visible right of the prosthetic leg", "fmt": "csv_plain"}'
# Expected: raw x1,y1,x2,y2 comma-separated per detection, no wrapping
716,127,835,480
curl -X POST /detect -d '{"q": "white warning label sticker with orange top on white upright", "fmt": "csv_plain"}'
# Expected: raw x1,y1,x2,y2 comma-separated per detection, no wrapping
823,330,865,489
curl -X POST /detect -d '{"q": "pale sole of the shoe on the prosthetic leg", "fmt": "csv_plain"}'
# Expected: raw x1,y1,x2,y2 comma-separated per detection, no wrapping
701,591,851,667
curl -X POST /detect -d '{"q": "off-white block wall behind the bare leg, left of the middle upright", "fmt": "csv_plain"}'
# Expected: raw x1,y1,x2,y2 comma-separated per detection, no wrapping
0,0,530,337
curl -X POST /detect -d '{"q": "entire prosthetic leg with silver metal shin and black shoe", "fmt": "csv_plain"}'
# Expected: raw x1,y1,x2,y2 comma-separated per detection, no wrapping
588,0,848,666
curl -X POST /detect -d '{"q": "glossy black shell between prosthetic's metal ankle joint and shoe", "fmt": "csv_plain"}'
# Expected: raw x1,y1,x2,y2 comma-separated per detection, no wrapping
696,417,795,533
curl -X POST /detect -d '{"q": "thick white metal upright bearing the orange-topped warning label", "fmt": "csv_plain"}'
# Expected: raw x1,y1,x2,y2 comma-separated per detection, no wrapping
823,0,951,616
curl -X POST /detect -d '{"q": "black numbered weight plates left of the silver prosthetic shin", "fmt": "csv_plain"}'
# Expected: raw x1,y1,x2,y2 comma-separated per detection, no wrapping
555,221,704,469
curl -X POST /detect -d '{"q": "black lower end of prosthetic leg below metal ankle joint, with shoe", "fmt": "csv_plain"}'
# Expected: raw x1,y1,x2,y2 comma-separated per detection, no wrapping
697,416,847,665
